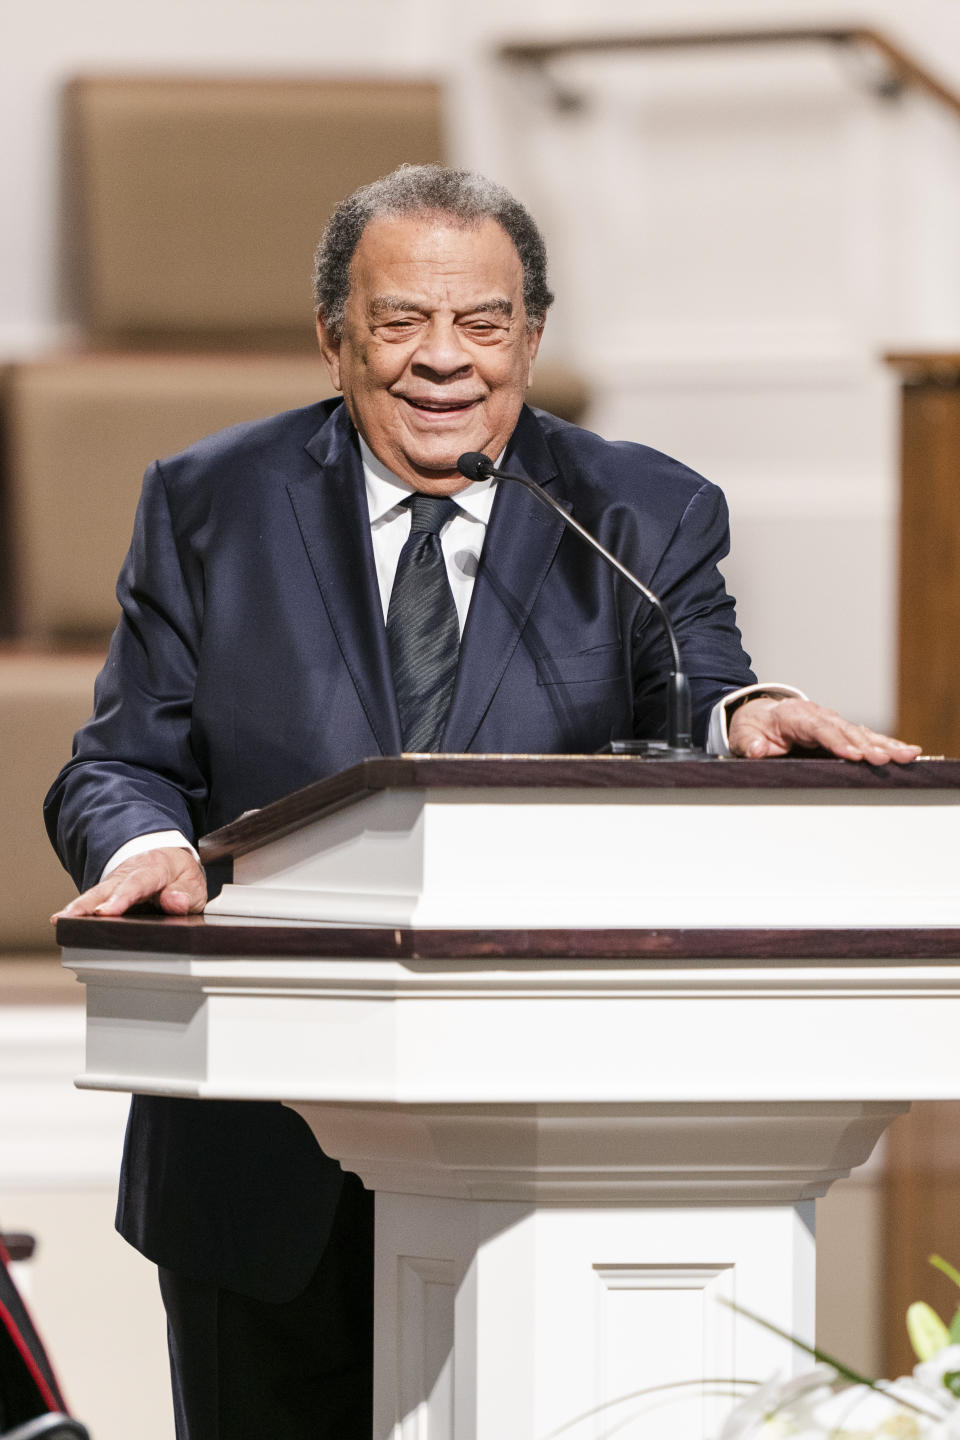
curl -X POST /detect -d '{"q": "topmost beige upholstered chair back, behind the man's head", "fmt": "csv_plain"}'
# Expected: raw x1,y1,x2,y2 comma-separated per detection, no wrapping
66,75,445,348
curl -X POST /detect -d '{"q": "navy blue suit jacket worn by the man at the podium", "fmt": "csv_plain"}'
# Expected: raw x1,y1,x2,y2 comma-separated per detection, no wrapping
46,402,754,1299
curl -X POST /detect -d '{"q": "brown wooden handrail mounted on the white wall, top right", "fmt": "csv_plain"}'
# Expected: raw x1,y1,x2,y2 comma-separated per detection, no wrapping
497,26,960,120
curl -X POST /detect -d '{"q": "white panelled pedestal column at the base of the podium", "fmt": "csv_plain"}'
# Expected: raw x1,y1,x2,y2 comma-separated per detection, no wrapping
374,1194,815,1440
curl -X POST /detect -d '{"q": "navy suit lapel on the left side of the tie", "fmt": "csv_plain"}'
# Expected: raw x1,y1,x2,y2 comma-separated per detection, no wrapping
286,405,400,755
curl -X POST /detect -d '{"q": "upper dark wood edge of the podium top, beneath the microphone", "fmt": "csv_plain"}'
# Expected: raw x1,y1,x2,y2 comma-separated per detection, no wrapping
199,755,960,864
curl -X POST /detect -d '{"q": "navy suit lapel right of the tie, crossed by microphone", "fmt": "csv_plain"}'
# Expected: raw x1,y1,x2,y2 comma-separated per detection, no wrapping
443,406,564,753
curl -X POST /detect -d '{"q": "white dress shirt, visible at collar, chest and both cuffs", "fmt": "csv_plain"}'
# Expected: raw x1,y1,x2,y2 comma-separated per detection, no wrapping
101,438,806,880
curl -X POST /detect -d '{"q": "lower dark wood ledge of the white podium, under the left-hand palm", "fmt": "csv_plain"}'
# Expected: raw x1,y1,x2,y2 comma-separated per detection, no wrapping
56,914,960,963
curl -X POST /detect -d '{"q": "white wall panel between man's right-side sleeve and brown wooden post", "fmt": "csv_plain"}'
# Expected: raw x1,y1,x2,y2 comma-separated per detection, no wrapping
592,357,898,729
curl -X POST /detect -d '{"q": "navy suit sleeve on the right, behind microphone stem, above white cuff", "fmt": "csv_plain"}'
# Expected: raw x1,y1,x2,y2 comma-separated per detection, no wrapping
633,481,756,744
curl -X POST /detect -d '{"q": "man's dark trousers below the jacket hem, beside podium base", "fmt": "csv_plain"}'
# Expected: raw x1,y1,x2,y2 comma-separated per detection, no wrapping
160,1176,373,1440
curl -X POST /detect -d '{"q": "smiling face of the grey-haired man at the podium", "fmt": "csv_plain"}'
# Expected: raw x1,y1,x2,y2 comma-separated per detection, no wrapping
317,215,543,495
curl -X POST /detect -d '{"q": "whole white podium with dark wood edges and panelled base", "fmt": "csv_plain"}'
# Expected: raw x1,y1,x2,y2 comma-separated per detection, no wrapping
59,756,960,1440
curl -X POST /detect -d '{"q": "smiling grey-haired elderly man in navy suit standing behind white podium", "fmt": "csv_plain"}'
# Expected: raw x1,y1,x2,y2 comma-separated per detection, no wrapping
47,166,917,1440
